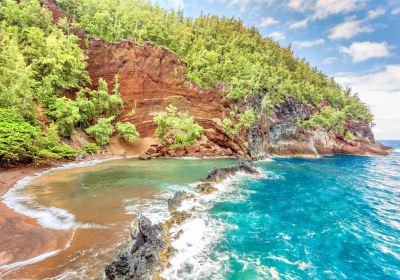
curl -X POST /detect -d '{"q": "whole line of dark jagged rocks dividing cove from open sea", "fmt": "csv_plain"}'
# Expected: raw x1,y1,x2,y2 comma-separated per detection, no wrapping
105,159,259,280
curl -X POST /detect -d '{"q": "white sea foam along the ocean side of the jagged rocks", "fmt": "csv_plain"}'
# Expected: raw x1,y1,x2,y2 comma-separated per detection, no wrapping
161,172,252,279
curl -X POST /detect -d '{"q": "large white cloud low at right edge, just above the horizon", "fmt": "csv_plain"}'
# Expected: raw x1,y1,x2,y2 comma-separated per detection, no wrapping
334,64,400,139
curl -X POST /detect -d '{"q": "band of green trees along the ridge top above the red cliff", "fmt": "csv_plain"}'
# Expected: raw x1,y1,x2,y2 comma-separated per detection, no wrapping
57,0,372,128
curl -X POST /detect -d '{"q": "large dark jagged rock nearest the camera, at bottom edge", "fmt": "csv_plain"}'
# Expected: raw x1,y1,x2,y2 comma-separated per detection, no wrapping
105,217,167,280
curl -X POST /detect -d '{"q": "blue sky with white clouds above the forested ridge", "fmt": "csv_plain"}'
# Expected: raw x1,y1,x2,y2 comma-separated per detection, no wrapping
153,0,400,140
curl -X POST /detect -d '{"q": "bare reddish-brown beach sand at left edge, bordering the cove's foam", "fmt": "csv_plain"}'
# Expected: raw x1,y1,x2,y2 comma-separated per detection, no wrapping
0,167,71,270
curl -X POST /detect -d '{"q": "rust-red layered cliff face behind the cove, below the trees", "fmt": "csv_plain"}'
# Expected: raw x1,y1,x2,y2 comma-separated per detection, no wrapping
86,40,247,156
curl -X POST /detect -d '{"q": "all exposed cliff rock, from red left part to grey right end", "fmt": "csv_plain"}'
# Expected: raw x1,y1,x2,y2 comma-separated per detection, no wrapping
46,1,387,159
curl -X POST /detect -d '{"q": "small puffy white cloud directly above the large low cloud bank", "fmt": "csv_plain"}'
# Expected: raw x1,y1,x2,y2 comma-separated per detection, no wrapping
340,41,390,62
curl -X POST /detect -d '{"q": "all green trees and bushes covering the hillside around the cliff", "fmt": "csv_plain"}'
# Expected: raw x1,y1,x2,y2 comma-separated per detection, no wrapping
0,0,380,166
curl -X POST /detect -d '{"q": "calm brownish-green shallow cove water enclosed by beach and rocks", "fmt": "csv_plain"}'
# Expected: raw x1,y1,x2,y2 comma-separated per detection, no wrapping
0,159,234,280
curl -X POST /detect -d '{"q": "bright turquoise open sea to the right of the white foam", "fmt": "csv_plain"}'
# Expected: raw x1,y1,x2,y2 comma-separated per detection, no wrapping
201,142,400,279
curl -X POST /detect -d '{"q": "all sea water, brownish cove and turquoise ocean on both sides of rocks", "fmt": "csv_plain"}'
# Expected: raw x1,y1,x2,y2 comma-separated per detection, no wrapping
0,141,400,280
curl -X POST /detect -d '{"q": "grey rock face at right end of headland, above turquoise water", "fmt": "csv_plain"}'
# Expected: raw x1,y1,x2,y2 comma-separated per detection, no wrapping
268,98,387,156
